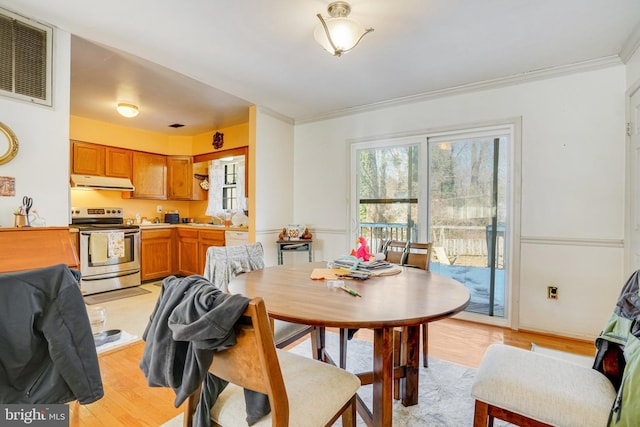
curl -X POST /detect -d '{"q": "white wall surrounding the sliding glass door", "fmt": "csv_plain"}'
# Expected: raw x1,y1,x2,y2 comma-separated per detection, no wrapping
294,65,625,339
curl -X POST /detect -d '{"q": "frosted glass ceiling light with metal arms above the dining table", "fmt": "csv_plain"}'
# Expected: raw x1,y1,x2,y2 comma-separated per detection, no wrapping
313,1,373,56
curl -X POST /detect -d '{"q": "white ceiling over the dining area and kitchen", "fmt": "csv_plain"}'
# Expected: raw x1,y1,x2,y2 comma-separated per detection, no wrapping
0,0,640,135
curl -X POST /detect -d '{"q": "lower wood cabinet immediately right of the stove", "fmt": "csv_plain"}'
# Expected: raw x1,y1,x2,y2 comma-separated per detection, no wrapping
140,228,174,281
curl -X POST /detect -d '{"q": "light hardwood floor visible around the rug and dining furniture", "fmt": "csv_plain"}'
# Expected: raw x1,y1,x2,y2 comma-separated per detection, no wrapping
70,319,595,427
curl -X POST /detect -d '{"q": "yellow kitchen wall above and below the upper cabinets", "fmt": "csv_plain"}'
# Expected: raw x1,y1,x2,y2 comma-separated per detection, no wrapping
69,116,249,222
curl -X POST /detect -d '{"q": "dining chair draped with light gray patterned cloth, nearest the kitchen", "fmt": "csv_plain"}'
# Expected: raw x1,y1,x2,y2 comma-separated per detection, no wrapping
204,242,313,348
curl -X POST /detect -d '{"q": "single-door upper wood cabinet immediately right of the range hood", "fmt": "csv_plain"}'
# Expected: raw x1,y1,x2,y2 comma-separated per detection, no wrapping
128,151,167,200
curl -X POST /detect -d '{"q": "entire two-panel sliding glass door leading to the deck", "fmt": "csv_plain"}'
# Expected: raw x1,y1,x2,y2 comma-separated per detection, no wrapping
352,127,513,317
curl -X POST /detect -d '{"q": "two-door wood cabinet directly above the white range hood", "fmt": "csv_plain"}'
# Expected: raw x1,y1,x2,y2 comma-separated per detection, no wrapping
71,141,132,178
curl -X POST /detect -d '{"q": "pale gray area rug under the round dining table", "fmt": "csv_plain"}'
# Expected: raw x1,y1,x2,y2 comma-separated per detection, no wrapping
163,333,510,427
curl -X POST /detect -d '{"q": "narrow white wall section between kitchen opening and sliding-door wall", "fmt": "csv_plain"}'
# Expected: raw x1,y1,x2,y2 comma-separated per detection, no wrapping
255,107,294,265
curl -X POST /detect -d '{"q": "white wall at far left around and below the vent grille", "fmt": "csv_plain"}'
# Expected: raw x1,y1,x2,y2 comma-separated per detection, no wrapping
0,30,71,227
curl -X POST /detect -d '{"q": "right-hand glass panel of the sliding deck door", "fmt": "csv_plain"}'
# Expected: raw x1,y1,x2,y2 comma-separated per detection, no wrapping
428,134,508,317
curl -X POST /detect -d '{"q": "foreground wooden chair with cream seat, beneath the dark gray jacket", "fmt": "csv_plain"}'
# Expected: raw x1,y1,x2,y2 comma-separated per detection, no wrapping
183,297,360,427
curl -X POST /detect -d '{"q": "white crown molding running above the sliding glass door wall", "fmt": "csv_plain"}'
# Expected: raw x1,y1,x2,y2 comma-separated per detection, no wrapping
295,55,623,125
